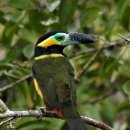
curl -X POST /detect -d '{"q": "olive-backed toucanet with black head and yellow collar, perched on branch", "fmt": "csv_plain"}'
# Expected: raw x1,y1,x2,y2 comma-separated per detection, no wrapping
32,31,94,130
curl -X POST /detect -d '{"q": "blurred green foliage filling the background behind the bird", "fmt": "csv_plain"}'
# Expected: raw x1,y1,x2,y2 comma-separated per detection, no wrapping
0,0,130,130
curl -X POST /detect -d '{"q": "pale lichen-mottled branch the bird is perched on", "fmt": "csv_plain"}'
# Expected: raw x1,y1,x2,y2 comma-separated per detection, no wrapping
0,100,113,130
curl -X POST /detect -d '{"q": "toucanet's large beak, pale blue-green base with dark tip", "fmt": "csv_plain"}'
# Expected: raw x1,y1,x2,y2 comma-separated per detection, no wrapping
62,32,95,45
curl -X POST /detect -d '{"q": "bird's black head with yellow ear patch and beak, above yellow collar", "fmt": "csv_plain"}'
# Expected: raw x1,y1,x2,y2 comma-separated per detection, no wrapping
35,31,94,56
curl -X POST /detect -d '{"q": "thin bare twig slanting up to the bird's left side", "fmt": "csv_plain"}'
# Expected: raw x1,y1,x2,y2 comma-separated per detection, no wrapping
0,74,32,92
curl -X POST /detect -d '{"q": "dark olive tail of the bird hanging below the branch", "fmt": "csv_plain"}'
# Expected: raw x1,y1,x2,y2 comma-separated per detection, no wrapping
63,104,87,130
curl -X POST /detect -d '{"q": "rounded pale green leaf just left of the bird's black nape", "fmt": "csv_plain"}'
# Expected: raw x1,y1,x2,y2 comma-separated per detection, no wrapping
23,44,34,59
